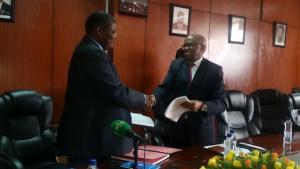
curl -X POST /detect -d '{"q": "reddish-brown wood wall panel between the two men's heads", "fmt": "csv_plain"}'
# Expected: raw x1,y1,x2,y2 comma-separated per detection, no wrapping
114,3,145,91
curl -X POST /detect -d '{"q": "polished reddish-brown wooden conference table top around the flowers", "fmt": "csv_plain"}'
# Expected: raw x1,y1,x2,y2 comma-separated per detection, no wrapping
100,132,300,169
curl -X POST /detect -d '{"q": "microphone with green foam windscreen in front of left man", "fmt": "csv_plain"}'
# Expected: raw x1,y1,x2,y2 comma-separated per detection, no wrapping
110,120,143,142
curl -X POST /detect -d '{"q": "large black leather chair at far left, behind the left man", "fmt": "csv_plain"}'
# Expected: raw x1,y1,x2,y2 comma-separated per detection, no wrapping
0,90,64,169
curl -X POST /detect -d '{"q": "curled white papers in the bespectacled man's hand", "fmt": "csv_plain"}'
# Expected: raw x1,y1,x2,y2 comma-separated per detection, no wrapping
165,96,190,122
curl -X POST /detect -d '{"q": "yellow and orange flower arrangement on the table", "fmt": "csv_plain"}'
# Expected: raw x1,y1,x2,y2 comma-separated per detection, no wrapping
200,150,300,169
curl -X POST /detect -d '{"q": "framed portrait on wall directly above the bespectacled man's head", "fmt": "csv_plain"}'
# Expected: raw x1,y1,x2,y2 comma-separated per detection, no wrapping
169,4,191,37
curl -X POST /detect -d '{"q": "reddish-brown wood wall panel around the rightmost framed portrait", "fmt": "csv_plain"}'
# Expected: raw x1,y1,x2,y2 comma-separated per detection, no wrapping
257,22,299,92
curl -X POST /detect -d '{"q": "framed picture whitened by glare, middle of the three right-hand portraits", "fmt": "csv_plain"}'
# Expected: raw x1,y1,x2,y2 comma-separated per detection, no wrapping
228,15,246,44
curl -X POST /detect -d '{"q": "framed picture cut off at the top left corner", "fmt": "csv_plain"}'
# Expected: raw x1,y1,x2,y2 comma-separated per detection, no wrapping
0,0,15,22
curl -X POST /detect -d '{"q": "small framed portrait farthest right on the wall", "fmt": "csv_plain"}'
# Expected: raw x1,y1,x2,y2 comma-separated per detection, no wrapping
273,21,287,48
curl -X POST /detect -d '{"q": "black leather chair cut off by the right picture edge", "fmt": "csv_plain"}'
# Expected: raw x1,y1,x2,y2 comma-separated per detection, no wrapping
289,93,300,131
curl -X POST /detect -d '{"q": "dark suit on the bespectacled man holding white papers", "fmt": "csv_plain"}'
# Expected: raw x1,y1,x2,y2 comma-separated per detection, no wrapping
154,57,225,145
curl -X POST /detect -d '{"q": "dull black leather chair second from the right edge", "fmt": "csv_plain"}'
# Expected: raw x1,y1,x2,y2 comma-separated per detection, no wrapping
251,89,290,135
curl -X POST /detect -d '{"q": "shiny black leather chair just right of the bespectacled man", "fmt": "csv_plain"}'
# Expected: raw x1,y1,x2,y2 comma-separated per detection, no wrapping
221,90,259,139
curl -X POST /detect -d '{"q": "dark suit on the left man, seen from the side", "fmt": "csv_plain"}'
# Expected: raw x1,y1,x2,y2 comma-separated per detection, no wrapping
58,37,145,157
